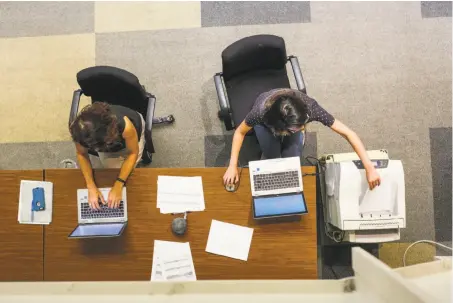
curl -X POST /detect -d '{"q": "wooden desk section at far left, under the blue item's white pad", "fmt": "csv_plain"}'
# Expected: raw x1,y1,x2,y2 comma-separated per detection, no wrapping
0,170,43,281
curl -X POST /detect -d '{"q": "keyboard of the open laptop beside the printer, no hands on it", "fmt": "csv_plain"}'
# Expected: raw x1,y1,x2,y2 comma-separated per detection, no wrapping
253,170,299,191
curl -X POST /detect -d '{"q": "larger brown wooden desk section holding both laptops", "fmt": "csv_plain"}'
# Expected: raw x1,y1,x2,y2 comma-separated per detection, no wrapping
44,167,317,281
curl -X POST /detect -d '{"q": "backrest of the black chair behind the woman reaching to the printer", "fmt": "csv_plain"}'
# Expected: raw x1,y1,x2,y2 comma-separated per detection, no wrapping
222,35,287,81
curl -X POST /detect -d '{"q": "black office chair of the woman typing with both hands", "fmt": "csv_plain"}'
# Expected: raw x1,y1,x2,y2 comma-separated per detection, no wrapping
69,66,175,164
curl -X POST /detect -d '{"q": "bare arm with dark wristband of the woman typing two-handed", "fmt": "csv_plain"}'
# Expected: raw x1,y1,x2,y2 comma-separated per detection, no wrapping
108,117,139,208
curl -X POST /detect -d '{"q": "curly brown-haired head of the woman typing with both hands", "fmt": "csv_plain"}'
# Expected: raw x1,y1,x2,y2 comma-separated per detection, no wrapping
69,102,119,151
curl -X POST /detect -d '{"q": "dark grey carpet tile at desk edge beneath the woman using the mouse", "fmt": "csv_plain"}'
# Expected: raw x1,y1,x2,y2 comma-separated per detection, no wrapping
204,133,317,167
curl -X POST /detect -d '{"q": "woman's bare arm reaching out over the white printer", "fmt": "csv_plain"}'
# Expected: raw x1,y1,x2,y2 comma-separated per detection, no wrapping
331,119,381,189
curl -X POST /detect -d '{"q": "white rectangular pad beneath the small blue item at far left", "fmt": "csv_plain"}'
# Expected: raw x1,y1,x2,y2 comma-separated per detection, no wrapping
17,180,53,224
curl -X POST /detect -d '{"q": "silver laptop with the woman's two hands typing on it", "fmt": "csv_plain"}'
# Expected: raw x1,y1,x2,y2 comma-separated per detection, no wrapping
69,187,127,238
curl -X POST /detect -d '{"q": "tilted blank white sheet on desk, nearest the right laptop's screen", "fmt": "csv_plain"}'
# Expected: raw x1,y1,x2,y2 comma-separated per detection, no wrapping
206,220,253,261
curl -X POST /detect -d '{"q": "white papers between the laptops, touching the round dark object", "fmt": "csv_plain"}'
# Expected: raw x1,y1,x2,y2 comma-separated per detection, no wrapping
157,176,205,214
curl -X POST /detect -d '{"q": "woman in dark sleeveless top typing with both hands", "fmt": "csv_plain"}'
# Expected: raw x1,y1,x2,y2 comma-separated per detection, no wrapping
69,102,145,209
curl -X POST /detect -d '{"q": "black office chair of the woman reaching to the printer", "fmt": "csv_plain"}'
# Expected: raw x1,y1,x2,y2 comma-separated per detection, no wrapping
214,35,306,135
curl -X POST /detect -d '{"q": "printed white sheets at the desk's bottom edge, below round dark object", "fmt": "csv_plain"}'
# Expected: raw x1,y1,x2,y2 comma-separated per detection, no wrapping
151,240,197,281
